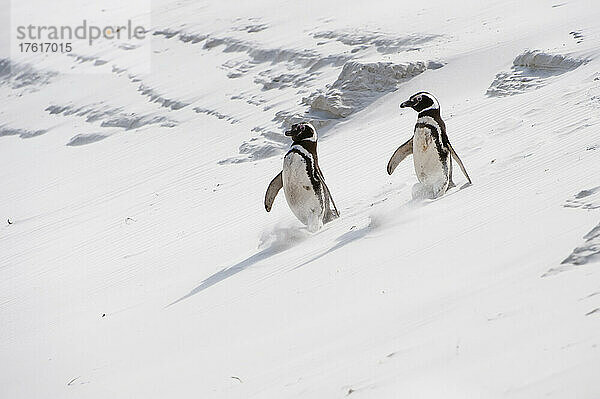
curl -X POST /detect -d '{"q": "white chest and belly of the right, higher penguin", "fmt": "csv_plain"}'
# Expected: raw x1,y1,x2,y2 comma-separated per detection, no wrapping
413,127,448,192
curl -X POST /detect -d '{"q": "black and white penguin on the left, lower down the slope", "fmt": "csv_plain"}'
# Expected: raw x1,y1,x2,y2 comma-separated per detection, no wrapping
265,123,340,233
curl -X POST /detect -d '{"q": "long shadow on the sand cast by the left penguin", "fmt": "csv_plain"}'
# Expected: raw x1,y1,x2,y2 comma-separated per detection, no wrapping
167,226,309,307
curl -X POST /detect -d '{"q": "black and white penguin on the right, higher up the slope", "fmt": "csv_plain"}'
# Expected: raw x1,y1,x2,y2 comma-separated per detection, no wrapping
387,92,471,198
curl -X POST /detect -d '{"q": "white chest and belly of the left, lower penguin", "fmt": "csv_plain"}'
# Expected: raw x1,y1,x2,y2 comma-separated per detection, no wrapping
282,151,324,231
